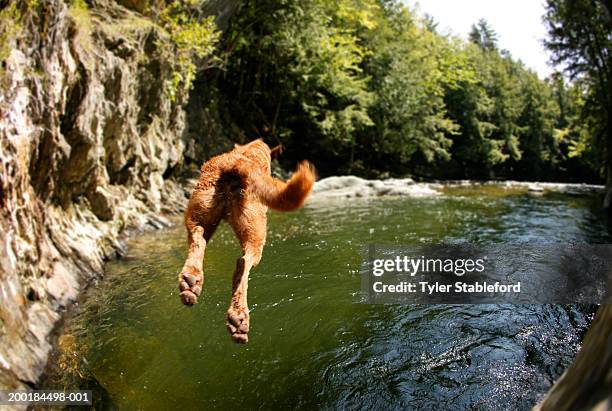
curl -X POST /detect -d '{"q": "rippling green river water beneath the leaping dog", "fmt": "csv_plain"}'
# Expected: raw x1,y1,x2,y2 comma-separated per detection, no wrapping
45,187,610,410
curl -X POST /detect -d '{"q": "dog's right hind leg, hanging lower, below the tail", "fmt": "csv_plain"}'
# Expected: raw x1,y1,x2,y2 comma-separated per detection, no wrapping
227,203,266,344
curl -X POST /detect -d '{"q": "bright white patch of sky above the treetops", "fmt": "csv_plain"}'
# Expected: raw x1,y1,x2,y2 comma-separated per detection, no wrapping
404,0,553,78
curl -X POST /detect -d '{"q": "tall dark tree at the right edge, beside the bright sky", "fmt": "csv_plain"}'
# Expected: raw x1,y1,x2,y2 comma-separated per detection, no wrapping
544,0,612,211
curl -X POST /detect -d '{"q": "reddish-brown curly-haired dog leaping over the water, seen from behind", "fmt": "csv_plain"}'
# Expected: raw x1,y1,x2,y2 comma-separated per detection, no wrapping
179,140,315,343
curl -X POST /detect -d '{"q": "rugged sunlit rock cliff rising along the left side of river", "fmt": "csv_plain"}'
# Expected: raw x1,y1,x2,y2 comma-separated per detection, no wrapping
0,0,233,388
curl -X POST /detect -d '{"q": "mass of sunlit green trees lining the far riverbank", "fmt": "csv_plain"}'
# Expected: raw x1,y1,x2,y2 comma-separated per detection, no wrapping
216,0,588,178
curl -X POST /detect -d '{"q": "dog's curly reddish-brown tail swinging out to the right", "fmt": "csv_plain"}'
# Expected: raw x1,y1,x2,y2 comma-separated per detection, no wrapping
250,161,316,211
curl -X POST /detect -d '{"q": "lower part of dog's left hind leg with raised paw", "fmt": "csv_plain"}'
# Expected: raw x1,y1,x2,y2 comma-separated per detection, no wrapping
179,225,206,305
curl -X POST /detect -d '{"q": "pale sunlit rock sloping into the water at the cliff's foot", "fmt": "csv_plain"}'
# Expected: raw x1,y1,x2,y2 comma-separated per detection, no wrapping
0,184,186,389
